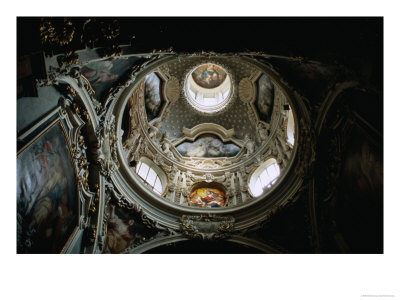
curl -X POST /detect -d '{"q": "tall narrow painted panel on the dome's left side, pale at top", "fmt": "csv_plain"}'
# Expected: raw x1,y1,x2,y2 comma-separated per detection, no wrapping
144,73,163,121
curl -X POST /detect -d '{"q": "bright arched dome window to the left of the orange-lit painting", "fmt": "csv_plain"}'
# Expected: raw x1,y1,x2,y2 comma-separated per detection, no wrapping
136,156,168,195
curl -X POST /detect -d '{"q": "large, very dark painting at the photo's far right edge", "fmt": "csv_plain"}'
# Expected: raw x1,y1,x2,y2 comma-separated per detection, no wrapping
334,126,383,253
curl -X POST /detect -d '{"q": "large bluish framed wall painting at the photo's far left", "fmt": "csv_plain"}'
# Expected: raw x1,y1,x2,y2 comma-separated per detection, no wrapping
17,123,78,253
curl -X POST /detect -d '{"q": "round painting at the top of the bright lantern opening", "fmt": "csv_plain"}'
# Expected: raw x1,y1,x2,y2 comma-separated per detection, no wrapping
192,64,227,89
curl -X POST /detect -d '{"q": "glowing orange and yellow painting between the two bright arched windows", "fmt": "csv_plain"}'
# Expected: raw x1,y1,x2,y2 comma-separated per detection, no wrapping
189,187,226,208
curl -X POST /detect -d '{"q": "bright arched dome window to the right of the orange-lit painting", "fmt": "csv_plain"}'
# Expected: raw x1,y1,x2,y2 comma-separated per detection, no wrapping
249,158,280,197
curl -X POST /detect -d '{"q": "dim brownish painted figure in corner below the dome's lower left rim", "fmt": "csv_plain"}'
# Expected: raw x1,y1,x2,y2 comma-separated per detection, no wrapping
103,206,135,253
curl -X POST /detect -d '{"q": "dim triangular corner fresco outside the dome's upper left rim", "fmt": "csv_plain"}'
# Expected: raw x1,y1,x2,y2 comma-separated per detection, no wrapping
81,57,138,100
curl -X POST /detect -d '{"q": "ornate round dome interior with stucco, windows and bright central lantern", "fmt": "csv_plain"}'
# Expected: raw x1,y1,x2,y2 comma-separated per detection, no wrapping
117,55,295,208
